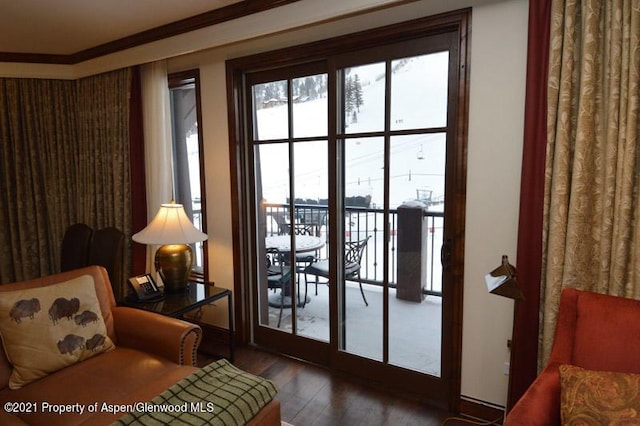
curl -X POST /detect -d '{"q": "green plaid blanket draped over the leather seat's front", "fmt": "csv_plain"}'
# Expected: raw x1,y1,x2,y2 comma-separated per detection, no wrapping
113,359,278,426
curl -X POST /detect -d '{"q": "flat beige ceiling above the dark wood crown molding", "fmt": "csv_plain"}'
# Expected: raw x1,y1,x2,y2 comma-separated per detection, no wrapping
0,0,245,55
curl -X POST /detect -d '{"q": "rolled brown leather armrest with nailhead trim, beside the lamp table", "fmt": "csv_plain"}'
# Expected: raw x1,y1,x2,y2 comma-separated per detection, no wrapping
112,306,202,366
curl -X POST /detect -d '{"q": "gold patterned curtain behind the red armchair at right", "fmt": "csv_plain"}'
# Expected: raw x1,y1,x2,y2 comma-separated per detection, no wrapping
539,0,640,365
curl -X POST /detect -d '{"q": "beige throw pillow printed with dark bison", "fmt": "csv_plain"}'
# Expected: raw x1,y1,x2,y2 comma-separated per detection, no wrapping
0,275,114,389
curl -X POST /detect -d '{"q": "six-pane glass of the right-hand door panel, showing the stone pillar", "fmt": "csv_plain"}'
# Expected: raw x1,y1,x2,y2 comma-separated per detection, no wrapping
339,51,449,377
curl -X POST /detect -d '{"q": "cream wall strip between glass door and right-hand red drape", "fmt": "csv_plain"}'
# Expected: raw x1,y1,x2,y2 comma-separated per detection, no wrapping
462,0,528,406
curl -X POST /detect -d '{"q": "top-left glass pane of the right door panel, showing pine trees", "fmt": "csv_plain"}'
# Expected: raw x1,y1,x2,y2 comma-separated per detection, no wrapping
341,62,385,134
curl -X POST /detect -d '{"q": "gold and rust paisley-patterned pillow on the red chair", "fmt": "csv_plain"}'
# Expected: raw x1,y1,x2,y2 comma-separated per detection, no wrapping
560,365,640,425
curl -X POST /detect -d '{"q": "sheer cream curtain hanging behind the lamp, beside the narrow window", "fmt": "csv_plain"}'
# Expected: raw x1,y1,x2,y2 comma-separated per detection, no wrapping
140,61,173,272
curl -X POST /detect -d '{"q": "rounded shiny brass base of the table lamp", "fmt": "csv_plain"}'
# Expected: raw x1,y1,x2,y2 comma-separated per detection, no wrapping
155,244,193,293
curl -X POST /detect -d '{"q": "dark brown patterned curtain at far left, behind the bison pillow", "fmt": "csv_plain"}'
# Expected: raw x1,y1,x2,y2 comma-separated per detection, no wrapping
0,79,80,283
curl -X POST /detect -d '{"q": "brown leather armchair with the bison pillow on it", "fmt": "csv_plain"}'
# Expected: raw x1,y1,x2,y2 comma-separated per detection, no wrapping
0,266,202,426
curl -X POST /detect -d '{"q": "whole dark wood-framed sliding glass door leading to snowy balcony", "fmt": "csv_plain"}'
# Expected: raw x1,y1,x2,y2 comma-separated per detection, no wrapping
230,11,466,405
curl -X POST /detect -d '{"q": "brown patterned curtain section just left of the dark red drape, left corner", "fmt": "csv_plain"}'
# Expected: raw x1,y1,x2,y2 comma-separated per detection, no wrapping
75,68,131,298
